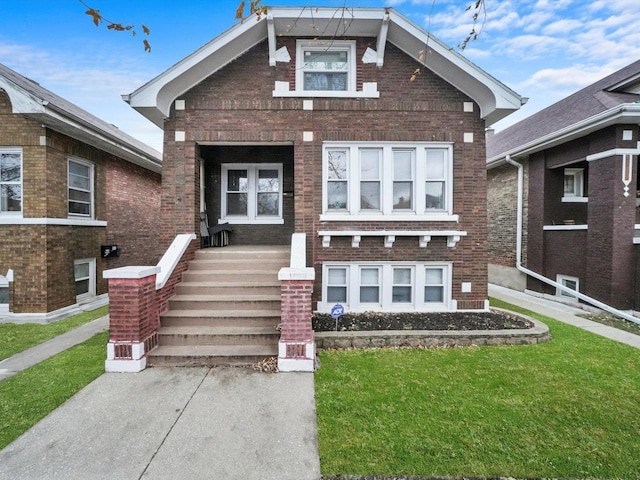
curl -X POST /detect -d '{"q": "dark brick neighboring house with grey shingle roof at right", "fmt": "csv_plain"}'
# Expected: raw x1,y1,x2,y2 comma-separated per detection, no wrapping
487,61,640,310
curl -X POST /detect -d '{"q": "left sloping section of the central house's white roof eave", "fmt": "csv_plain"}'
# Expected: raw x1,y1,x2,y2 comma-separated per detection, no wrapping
122,15,267,128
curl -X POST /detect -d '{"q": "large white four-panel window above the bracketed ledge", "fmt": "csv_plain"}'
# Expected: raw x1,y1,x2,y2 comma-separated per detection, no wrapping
323,142,453,220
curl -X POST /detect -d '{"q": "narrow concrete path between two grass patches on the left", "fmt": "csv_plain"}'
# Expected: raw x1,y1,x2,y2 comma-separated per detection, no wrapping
0,315,109,382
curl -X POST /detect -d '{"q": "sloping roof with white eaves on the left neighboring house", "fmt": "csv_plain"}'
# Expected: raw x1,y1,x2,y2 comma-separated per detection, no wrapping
0,63,162,173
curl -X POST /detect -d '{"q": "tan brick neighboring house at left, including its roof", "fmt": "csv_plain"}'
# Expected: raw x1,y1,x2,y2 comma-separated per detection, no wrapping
0,64,162,322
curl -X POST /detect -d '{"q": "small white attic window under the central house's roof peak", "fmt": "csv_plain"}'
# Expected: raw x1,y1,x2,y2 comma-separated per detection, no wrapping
296,40,356,92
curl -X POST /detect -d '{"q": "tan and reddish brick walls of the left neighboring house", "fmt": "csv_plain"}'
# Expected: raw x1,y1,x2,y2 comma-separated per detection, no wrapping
0,90,160,313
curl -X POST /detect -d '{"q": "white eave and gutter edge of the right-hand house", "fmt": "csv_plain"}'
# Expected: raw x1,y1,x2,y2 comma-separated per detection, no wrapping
487,103,640,169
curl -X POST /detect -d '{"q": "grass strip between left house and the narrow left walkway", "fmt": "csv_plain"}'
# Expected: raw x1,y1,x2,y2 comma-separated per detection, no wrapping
0,306,109,360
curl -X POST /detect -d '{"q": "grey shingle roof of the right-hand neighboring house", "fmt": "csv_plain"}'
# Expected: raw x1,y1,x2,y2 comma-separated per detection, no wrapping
487,60,640,167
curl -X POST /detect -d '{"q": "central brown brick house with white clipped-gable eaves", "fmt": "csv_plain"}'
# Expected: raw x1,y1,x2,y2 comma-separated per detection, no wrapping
125,8,522,311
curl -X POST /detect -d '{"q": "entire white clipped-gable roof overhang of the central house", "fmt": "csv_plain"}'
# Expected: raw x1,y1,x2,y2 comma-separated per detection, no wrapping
123,7,526,128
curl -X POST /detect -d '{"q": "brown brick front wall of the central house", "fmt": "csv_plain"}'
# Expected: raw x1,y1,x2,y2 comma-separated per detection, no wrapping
162,38,487,308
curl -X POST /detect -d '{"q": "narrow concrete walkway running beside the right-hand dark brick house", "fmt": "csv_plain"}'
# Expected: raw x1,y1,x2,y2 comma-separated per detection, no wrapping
489,285,640,348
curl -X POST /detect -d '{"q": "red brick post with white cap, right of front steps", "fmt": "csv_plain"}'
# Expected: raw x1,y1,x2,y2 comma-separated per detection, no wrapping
278,233,316,372
